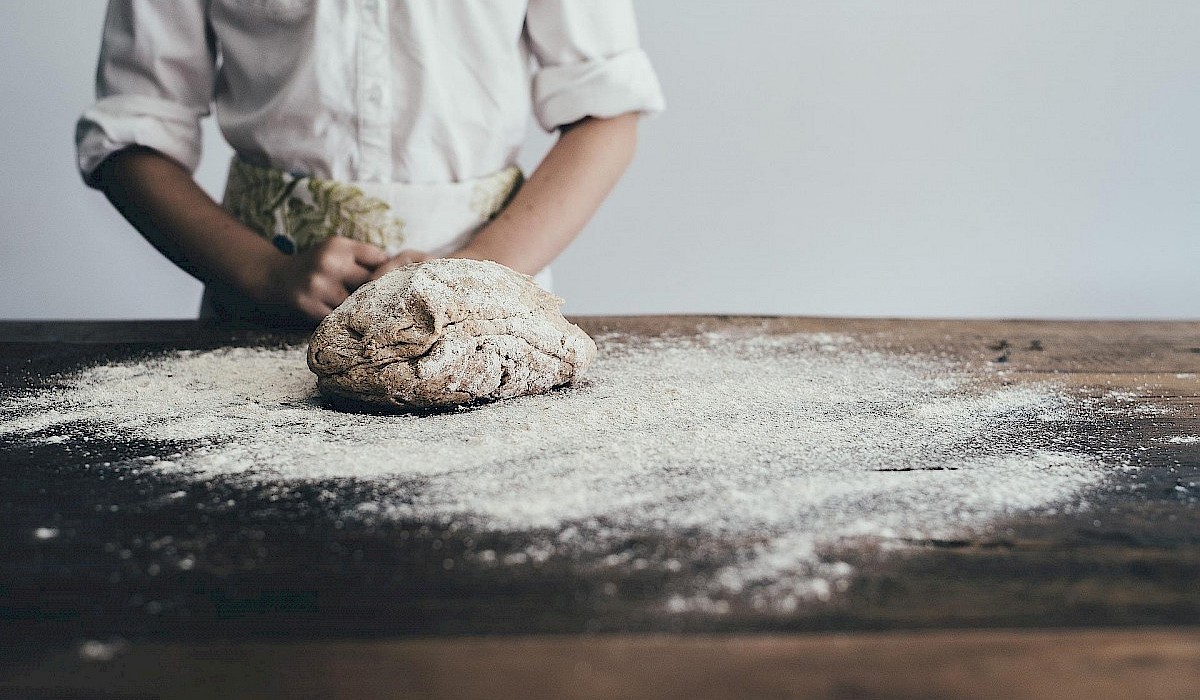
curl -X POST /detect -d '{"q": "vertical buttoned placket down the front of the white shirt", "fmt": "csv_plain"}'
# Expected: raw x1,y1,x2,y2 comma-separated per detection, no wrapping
358,0,392,183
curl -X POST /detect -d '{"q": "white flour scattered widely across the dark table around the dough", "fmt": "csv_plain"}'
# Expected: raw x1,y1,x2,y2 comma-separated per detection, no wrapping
0,333,1105,611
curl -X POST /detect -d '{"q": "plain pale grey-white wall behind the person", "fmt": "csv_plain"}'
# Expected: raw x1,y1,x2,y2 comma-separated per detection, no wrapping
0,0,1200,318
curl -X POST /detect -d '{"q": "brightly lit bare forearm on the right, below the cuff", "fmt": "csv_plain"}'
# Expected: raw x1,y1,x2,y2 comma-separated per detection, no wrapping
454,114,638,275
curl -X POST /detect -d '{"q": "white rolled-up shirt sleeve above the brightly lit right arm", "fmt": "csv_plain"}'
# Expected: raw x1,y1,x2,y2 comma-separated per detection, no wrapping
526,0,665,131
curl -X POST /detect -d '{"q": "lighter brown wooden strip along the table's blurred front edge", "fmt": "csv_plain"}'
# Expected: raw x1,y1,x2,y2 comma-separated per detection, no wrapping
0,629,1200,700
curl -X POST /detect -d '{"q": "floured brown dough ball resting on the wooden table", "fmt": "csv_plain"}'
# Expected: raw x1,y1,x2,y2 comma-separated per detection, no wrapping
308,259,596,409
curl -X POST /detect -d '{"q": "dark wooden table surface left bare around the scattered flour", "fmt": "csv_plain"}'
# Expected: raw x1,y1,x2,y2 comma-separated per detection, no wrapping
0,317,1200,698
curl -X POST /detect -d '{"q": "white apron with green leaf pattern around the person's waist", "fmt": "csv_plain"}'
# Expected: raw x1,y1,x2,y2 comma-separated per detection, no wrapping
200,157,551,324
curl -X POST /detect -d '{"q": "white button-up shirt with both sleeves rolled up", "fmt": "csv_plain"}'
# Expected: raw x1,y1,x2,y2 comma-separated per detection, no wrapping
76,0,664,183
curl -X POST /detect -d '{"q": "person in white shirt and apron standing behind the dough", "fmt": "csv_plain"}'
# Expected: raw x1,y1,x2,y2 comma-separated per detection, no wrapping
76,0,664,324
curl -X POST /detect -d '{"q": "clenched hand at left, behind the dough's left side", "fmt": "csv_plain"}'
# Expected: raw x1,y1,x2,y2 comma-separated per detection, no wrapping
252,237,389,321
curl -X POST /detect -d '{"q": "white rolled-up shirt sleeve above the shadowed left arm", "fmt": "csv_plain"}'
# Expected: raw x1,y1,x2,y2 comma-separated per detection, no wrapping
76,0,216,185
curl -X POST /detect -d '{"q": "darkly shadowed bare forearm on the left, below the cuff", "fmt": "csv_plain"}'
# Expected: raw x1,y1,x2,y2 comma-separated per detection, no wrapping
97,148,283,297
